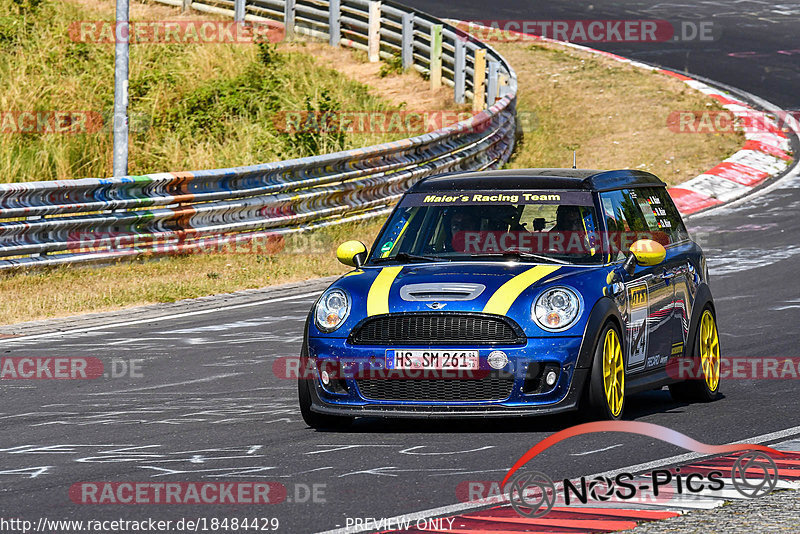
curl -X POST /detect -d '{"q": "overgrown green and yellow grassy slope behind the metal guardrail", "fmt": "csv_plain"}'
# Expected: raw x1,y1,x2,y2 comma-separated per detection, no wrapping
0,0,412,182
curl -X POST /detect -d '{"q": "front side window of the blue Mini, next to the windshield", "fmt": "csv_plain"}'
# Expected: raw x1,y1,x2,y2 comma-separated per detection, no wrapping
600,189,650,262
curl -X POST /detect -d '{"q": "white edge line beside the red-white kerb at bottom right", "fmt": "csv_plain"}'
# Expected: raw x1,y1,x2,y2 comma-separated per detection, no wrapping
317,426,800,534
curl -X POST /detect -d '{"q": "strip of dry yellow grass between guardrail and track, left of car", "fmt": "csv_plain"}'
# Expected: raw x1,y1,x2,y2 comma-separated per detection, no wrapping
0,222,382,324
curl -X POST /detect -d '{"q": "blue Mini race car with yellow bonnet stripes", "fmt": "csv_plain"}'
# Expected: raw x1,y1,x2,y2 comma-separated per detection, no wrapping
298,169,720,428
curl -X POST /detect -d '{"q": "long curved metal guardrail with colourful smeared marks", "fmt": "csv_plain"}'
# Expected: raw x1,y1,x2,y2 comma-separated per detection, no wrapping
0,0,517,270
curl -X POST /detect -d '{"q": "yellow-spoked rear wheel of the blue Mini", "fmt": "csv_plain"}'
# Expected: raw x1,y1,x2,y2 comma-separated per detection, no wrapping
669,306,720,402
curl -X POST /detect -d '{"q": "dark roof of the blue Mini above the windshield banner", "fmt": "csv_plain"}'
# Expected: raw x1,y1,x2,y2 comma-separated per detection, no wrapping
410,169,666,193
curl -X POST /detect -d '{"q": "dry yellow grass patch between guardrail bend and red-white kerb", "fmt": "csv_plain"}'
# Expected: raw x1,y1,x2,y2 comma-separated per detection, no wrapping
498,43,744,185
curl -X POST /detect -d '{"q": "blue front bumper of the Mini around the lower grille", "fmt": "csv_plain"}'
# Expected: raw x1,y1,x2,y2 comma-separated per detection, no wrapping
308,337,588,418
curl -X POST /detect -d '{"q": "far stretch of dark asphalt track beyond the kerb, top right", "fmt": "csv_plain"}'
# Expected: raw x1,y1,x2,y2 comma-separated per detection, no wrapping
405,0,800,110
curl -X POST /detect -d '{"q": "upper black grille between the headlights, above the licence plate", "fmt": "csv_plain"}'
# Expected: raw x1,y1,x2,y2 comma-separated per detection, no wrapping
350,312,525,345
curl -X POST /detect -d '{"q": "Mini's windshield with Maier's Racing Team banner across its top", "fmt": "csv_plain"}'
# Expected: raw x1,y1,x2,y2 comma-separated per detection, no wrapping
370,190,603,264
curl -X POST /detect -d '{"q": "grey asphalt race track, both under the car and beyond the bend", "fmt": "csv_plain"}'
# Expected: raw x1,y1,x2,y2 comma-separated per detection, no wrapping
0,0,800,533
